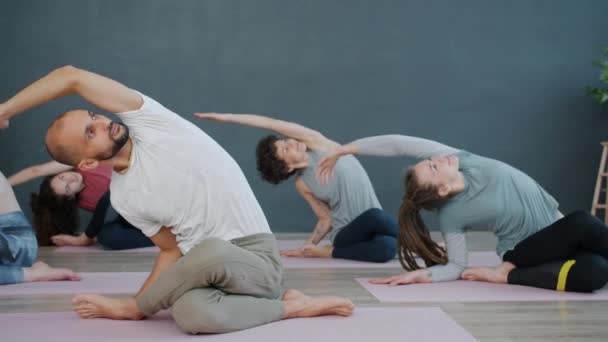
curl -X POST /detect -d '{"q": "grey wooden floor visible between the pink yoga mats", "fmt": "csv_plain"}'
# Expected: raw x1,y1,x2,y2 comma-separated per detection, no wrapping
0,233,608,342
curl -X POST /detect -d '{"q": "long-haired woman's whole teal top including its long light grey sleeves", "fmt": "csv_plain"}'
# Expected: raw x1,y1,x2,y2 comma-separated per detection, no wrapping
353,135,561,282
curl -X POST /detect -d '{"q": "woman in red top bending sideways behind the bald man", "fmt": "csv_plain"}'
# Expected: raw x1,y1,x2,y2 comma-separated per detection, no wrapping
9,161,153,250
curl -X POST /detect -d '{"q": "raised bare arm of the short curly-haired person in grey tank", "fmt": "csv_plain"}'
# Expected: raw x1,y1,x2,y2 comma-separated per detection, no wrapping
194,113,338,150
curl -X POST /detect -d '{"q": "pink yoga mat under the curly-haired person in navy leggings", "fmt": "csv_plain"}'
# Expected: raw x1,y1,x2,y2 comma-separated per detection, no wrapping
282,252,500,268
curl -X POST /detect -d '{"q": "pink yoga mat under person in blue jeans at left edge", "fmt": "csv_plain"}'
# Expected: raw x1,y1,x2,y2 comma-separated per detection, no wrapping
0,272,148,296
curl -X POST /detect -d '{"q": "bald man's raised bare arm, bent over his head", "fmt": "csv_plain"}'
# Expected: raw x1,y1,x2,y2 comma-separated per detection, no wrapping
0,66,143,128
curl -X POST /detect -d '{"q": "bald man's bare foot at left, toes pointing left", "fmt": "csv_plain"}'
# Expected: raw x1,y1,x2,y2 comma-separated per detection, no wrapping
72,295,144,320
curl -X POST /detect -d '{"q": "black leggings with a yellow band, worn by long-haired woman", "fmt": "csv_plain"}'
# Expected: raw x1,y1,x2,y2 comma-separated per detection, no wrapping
503,211,608,292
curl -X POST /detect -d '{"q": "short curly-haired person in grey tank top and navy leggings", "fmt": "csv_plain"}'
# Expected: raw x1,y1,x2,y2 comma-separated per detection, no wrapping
195,113,397,262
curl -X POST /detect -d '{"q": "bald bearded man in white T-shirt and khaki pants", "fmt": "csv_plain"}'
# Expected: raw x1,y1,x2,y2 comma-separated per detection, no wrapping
0,66,354,333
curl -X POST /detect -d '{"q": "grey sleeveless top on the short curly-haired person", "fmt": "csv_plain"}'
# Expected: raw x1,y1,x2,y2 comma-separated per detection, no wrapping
300,150,382,241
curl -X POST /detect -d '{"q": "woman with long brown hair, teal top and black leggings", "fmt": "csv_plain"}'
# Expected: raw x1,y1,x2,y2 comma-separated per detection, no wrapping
319,135,608,292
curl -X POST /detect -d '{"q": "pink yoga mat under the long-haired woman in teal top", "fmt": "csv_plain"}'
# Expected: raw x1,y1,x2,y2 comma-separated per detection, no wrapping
357,274,608,303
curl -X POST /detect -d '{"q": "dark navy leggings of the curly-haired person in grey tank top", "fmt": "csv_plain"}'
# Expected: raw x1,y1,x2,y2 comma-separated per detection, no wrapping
332,208,399,262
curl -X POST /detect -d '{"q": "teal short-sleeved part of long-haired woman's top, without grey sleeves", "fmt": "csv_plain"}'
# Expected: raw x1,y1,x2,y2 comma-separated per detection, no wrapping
438,151,559,256
